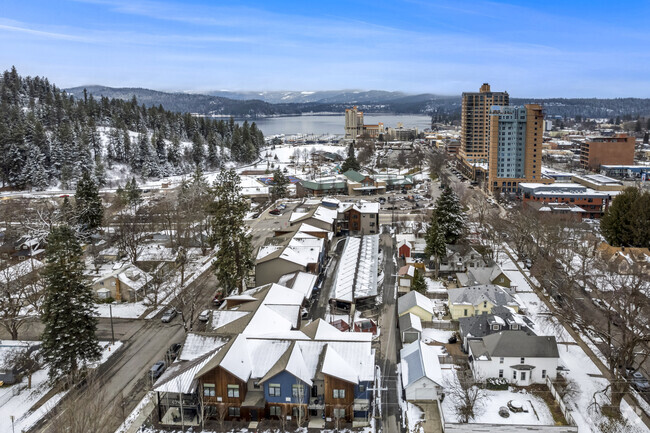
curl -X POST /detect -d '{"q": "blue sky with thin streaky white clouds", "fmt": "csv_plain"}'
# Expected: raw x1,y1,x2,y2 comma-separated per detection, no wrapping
0,0,650,97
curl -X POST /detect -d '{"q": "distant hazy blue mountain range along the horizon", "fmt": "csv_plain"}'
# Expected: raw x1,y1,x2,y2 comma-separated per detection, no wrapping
65,86,650,118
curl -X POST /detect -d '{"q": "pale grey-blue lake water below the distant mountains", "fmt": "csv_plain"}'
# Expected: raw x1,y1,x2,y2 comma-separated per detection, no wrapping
240,114,431,136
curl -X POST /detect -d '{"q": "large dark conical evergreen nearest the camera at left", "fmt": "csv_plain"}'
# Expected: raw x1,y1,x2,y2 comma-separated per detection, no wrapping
41,226,101,384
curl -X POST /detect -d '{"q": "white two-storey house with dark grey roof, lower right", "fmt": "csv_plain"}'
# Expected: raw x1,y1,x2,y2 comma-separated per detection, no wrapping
469,331,560,386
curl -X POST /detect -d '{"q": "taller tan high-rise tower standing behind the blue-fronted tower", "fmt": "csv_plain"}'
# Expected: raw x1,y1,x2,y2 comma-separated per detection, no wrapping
459,83,510,166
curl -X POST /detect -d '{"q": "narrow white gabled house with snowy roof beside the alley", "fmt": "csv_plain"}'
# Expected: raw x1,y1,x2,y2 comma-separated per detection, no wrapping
399,340,442,401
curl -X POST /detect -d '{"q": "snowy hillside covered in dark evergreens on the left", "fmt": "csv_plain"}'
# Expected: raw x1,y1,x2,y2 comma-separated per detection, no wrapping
0,68,264,189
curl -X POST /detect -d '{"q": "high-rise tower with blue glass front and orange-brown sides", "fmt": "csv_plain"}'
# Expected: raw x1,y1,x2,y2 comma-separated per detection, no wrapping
487,104,544,194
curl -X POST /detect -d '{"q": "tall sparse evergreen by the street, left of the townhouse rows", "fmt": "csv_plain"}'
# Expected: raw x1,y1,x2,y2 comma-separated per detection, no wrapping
210,169,253,292
